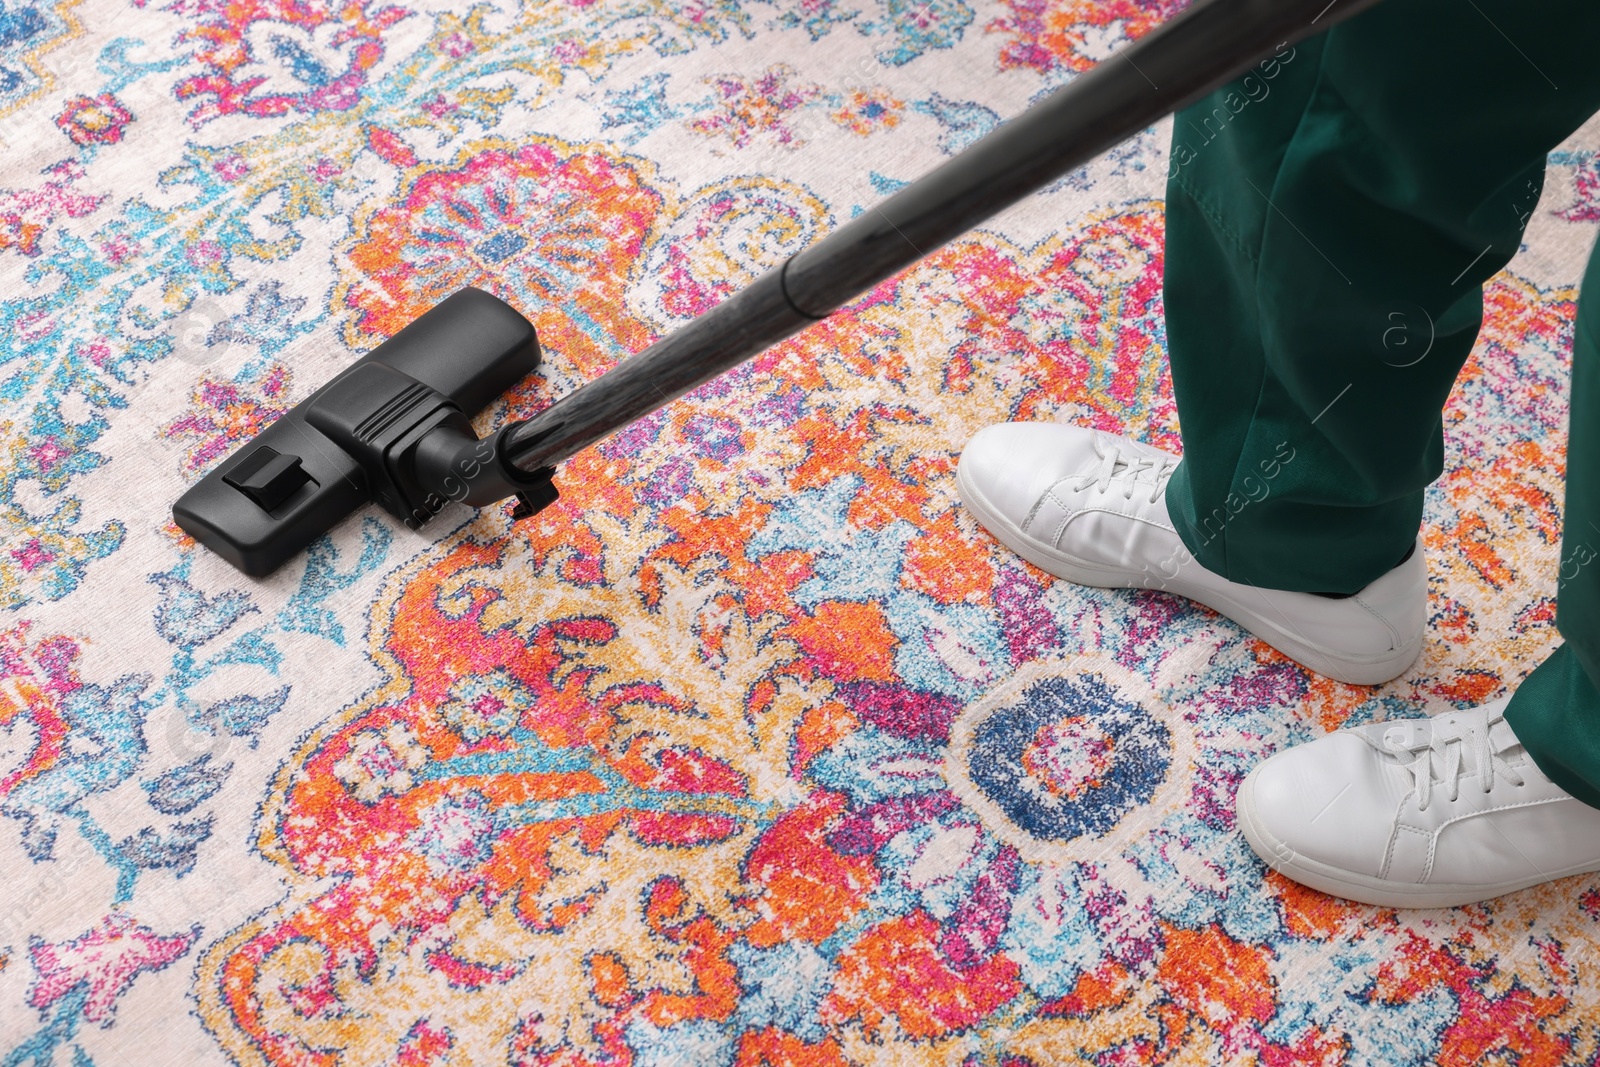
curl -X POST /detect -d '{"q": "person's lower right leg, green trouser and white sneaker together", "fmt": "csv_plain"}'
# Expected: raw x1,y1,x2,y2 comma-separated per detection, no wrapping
1237,241,1600,907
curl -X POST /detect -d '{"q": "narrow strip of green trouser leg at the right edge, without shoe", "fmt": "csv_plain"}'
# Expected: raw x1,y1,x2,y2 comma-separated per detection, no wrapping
1506,241,1600,808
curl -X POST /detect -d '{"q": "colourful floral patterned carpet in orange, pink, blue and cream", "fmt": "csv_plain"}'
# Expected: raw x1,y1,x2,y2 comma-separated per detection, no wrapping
9,0,1600,1067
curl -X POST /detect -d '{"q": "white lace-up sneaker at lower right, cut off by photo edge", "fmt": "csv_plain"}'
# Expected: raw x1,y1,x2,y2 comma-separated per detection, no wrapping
1237,701,1600,907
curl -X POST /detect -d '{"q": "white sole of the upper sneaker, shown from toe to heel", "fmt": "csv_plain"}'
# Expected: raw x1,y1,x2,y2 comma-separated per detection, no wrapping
955,464,1422,685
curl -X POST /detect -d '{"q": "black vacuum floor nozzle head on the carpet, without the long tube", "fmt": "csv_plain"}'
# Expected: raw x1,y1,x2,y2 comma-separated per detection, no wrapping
173,288,555,577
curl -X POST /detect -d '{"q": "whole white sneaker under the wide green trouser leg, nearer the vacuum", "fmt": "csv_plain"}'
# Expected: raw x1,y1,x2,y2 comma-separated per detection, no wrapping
955,422,1427,685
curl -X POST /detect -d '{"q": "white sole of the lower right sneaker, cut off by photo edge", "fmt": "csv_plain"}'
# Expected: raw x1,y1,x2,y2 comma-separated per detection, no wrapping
1234,768,1600,907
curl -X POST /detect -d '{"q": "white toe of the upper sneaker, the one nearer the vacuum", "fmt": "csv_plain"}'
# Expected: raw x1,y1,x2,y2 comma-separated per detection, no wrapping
957,422,1098,526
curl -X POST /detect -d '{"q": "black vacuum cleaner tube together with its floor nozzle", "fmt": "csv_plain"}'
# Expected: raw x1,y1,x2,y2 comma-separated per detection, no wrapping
173,0,1378,576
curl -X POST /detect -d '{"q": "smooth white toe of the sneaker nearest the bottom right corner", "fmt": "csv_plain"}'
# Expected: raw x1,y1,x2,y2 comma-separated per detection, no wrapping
1242,731,1400,877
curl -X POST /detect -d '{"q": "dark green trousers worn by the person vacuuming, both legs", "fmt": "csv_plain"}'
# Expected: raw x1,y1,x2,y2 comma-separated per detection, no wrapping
1166,0,1600,806
